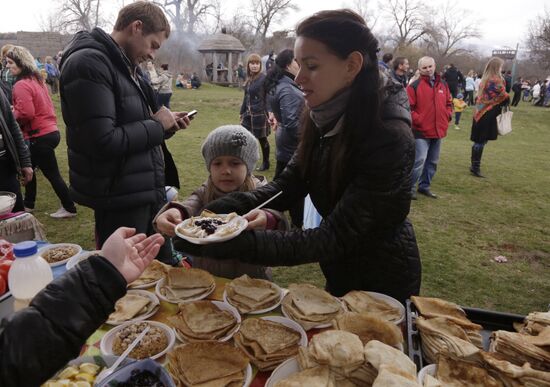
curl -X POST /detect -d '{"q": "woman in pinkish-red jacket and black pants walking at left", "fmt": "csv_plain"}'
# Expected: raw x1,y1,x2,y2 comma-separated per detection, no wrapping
6,46,76,218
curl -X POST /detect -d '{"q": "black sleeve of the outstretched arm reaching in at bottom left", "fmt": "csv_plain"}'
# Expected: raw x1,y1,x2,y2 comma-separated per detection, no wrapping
0,256,126,387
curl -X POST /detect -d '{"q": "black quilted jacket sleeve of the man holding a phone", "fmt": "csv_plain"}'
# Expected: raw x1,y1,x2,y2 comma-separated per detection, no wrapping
61,50,165,158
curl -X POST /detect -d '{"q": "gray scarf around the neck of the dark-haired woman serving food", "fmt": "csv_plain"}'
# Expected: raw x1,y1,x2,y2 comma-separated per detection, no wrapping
309,88,351,137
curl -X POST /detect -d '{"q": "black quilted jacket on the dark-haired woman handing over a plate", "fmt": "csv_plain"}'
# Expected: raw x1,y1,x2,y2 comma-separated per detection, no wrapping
176,77,421,302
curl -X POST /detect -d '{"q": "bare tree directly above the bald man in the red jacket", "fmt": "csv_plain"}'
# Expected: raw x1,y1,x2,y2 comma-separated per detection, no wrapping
379,0,429,49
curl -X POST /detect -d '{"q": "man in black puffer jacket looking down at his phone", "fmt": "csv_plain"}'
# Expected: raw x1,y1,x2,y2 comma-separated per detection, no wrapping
60,2,189,263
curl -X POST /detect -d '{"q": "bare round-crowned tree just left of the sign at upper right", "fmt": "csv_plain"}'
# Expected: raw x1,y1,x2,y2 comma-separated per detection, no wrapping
424,1,481,59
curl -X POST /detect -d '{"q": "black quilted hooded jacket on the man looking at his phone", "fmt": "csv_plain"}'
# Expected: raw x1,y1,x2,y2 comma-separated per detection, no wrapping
60,28,165,209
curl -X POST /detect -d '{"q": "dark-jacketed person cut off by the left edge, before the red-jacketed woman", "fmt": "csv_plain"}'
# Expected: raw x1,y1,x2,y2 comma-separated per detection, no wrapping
0,89,33,212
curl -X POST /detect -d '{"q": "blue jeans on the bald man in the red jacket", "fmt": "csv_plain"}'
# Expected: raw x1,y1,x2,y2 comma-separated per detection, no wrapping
411,138,441,192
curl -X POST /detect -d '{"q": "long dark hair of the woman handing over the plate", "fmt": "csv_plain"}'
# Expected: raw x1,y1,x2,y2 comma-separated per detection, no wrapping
296,9,381,200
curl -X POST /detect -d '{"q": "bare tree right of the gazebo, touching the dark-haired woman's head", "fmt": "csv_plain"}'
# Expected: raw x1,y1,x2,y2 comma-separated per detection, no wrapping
251,0,298,49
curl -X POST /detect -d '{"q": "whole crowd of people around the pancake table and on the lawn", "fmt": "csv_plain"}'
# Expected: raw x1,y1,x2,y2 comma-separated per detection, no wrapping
0,2,541,386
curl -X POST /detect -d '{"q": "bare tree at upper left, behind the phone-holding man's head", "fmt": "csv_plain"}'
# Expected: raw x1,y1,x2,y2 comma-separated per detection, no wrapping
52,0,104,32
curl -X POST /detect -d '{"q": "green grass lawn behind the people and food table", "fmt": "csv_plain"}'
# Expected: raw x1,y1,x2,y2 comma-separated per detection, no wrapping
35,85,550,313
